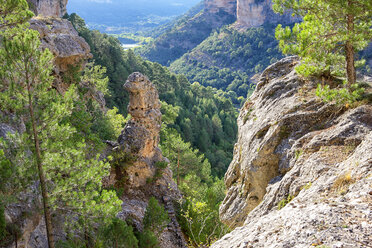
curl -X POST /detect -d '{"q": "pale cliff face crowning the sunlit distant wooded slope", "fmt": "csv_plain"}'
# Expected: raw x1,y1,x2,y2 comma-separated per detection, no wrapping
236,0,296,28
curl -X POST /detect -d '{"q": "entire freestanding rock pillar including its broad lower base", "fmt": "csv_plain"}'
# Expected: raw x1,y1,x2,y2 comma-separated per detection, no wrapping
110,72,186,248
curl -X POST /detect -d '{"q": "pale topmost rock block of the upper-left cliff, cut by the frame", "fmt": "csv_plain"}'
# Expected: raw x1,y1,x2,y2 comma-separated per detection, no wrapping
27,0,68,17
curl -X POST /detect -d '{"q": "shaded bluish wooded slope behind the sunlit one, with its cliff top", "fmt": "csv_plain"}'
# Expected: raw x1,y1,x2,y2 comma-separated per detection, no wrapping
138,0,236,65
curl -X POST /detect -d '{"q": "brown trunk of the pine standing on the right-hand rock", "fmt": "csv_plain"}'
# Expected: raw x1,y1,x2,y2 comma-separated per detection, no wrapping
345,0,356,91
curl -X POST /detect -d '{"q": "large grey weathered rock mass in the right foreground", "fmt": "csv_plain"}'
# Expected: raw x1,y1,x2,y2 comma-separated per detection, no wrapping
212,57,372,248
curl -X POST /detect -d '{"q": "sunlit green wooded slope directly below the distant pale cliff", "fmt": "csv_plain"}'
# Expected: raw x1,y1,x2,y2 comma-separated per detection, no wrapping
170,25,282,103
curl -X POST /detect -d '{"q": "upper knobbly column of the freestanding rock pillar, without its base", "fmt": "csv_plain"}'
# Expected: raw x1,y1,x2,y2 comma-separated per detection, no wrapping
118,73,163,187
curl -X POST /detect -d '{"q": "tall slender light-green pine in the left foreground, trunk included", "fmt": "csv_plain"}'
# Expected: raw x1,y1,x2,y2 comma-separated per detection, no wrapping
0,1,121,248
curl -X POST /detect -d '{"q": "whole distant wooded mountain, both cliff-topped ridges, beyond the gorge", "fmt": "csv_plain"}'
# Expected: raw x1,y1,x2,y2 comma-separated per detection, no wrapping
136,0,296,106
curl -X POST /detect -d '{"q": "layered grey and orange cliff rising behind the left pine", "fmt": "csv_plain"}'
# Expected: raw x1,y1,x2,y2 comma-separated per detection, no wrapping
29,0,92,92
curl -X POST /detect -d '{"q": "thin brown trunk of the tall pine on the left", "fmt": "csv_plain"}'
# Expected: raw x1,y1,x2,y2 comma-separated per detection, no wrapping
27,82,54,248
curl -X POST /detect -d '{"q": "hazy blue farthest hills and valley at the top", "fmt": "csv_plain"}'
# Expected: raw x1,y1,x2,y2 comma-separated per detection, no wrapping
67,0,200,34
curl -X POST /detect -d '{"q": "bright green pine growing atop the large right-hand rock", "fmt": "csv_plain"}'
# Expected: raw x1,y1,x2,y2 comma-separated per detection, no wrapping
273,0,372,90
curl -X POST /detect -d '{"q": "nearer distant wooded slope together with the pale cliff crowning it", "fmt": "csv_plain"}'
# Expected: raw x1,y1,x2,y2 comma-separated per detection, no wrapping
170,0,296,104
